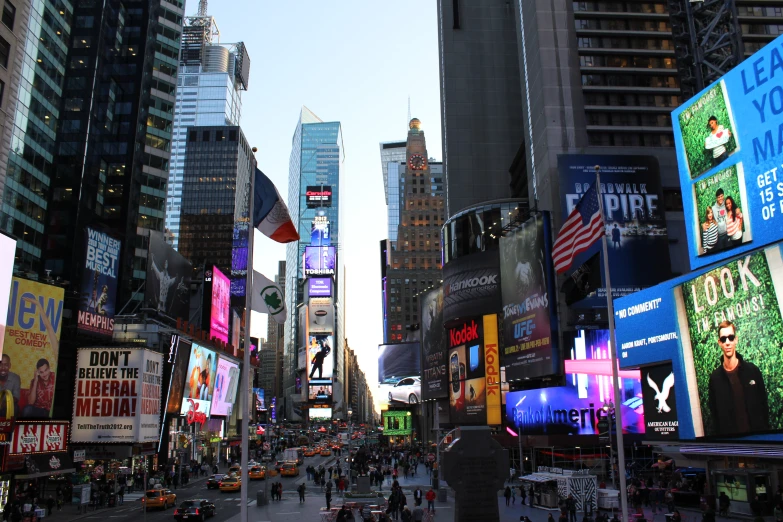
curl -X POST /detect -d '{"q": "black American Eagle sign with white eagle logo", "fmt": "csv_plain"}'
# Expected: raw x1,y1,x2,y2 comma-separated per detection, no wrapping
642,361,680,440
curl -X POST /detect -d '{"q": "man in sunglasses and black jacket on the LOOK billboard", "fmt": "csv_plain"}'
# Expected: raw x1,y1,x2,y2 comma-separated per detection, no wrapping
705,321,769,435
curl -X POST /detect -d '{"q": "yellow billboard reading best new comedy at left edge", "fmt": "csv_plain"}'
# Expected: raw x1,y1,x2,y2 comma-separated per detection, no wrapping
0,277,65,418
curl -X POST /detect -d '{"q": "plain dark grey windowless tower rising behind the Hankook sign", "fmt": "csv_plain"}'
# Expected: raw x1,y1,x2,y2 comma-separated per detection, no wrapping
438,0,524,217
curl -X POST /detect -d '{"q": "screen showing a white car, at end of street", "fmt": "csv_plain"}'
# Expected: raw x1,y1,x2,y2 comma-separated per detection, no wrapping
378,343,421,404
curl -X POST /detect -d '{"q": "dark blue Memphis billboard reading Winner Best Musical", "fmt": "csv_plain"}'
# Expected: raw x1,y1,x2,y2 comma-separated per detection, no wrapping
76,227,121,337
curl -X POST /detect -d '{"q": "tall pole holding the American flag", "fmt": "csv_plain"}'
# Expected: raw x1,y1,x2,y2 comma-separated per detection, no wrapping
595,165,628,522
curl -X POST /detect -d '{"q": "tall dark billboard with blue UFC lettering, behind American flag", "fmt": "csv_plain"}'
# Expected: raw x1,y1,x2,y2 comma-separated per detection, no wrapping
500,213,559,380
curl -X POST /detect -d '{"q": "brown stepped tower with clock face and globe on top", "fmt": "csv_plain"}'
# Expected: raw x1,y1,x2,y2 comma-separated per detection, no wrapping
384,118,444,342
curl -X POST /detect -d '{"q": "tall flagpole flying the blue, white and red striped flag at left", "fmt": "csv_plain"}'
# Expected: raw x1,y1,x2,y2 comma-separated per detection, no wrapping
239,147,258,522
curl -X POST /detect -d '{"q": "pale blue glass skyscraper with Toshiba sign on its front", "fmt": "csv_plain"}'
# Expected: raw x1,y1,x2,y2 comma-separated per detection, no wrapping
283,107,345,420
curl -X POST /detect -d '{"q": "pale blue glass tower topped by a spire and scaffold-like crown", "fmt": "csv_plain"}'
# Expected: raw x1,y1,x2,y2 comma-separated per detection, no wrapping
165,0,250,248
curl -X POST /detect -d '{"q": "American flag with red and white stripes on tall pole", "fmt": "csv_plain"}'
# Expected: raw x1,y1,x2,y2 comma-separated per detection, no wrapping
552,185,604,274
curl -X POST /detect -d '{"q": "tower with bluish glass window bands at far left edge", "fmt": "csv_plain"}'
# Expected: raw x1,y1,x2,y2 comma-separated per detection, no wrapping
0,0,73,278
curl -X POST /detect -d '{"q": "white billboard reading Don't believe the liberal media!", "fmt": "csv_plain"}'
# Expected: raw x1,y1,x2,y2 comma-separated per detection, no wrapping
71,348,163,443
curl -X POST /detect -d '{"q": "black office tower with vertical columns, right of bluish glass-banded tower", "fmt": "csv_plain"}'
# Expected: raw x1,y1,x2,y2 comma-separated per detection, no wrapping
12,0,183,304
